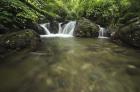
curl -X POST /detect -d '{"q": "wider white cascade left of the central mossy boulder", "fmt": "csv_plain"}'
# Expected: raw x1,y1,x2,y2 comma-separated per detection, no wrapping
41,21,76,37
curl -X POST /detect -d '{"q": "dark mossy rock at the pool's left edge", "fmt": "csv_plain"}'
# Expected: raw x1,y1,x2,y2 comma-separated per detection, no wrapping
0,29,40,50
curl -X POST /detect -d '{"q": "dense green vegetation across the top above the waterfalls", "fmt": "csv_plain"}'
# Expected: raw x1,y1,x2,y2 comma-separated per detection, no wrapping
0,0,140,25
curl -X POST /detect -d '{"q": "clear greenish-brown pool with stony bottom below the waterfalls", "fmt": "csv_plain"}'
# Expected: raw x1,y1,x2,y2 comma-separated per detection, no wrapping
0,38,140,92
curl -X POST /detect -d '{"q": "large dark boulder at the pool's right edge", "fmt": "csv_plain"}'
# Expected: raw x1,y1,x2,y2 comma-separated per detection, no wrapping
112,18,140,48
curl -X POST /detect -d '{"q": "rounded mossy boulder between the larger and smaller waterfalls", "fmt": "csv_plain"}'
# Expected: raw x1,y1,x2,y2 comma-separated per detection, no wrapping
74,18,99,37
